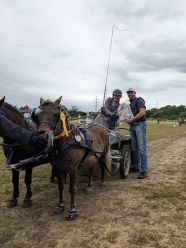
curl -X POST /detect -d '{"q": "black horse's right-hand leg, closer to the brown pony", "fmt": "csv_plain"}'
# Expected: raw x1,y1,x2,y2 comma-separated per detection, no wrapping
23,168,32,208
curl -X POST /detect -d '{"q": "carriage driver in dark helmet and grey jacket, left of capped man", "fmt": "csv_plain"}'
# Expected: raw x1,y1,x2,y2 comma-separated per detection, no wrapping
94,89,122,129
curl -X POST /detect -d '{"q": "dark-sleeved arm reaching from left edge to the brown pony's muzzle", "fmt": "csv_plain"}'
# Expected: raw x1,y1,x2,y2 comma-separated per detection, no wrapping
0,114,48,149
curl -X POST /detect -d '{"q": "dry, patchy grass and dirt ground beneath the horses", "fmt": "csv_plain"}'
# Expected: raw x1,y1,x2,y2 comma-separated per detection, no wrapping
0,132,186,248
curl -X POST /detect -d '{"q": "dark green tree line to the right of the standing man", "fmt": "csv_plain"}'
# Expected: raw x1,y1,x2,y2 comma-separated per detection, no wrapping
146,105,186,120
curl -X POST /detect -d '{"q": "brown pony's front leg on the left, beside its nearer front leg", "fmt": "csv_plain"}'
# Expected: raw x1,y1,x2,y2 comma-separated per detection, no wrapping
54,173,66,214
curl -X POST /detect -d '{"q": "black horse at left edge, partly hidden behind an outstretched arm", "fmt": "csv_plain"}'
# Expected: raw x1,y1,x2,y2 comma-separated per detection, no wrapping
0,97,50,207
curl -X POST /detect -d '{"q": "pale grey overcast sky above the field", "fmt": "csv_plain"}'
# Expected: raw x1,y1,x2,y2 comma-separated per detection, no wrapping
0,0,186,110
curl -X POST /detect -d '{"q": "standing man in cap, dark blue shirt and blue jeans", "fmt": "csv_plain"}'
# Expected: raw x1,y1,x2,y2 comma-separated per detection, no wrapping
126,88,148,179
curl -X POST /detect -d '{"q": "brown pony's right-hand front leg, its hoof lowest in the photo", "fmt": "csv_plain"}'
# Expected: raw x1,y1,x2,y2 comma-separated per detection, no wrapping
66,170,77,220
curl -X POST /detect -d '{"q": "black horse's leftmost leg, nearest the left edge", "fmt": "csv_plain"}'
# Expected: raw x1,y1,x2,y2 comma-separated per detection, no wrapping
7,170,19,208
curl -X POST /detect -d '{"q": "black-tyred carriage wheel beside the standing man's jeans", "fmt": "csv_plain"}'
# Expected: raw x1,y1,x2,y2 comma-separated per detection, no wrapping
119,145,131,179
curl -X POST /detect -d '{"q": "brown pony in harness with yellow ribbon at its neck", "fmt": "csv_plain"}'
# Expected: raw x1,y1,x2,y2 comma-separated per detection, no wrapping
33,97,111,220
